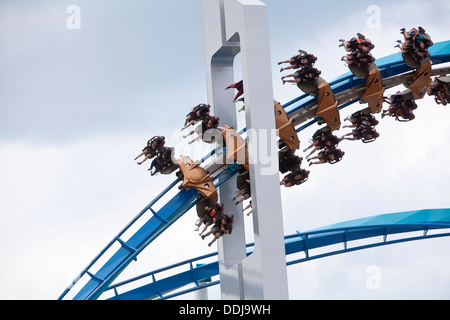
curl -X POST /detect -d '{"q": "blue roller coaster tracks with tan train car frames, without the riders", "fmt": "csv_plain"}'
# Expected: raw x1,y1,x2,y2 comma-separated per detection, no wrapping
59,3,450,300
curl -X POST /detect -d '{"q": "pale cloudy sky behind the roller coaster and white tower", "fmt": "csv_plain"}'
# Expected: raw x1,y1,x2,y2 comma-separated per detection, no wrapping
0,0,450,299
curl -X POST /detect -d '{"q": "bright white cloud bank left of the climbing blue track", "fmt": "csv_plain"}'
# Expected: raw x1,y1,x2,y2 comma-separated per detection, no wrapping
0,136,177,299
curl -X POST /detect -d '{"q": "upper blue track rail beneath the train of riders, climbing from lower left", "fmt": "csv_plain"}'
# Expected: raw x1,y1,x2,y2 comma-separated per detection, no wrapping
59,40,450,299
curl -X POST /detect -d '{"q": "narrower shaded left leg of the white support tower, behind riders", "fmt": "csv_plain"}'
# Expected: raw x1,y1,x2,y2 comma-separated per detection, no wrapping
202,0,246,300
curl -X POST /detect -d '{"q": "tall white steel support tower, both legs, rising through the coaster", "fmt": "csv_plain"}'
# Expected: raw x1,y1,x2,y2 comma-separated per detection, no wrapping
202,0,289,300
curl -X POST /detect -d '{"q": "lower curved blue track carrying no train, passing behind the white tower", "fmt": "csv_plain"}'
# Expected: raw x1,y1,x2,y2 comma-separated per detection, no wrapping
108,209,450,300
